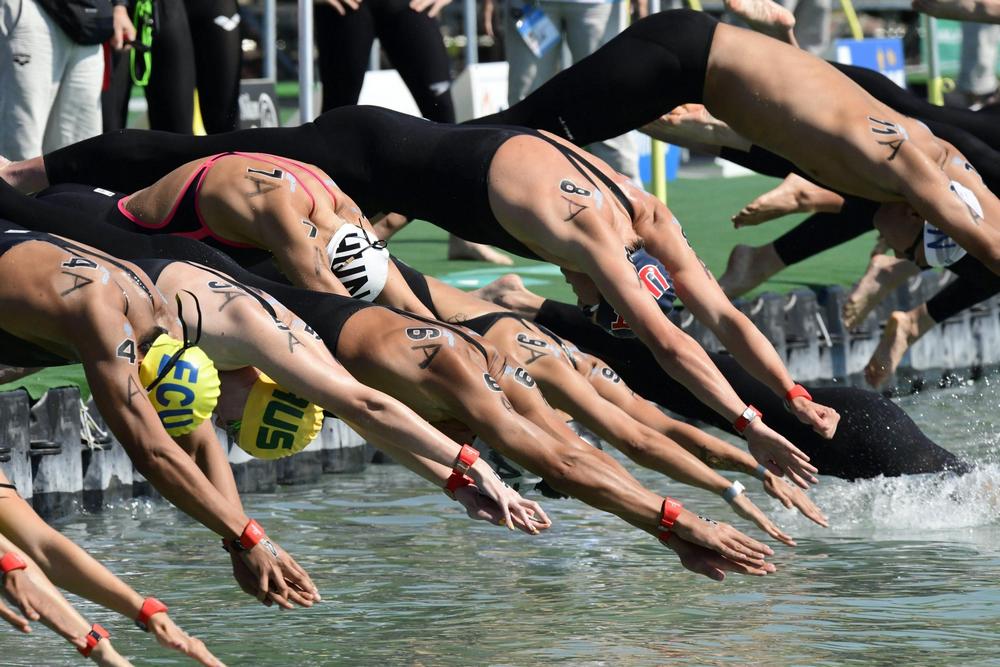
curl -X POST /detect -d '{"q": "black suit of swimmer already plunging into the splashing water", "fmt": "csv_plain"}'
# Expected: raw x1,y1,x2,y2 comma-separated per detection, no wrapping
535,300,968,479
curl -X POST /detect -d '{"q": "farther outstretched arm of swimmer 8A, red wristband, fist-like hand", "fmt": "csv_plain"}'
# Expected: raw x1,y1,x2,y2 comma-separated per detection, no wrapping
636,197,840,439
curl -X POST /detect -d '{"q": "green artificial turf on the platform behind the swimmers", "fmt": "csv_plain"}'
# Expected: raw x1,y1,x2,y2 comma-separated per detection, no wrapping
3,176,874,398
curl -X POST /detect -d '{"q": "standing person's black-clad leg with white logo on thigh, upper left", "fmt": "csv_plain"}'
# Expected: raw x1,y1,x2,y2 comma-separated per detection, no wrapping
184,0,243,134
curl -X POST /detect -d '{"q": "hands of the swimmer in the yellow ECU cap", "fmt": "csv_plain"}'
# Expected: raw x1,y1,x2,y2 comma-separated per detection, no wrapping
230,540,321,609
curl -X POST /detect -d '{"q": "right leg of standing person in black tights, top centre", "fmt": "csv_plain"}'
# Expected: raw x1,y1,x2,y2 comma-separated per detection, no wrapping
374,0,455,123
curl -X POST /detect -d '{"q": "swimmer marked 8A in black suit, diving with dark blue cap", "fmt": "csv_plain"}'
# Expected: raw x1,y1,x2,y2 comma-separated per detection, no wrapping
9,113,838,487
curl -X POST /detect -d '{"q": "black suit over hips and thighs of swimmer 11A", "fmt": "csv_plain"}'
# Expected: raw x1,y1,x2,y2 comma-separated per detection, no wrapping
470,9,716,145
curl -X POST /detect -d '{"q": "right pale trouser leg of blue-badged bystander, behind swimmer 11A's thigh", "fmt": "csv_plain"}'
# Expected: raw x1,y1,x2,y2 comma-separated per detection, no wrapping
565,2,639,180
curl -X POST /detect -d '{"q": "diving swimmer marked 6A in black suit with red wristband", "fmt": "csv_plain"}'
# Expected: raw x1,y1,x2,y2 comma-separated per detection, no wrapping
9,188,774,580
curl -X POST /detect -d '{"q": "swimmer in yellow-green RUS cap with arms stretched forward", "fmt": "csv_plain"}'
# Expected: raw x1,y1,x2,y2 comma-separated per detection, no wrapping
101,259,551,534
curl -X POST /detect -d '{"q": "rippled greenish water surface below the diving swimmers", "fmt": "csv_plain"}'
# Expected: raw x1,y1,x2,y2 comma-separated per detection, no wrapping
0,378,1000,665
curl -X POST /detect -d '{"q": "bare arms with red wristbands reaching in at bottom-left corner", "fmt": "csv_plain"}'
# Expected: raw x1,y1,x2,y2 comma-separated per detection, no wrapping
0,471,222,667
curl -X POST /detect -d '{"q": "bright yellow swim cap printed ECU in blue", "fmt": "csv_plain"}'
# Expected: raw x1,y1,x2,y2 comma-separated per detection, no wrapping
139,334,219,436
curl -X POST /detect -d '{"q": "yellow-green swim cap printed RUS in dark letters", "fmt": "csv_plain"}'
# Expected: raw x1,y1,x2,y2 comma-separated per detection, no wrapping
236,373,323,459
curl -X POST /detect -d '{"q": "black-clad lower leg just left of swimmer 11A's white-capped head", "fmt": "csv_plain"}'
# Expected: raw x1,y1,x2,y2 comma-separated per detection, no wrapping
774,197,879,266
